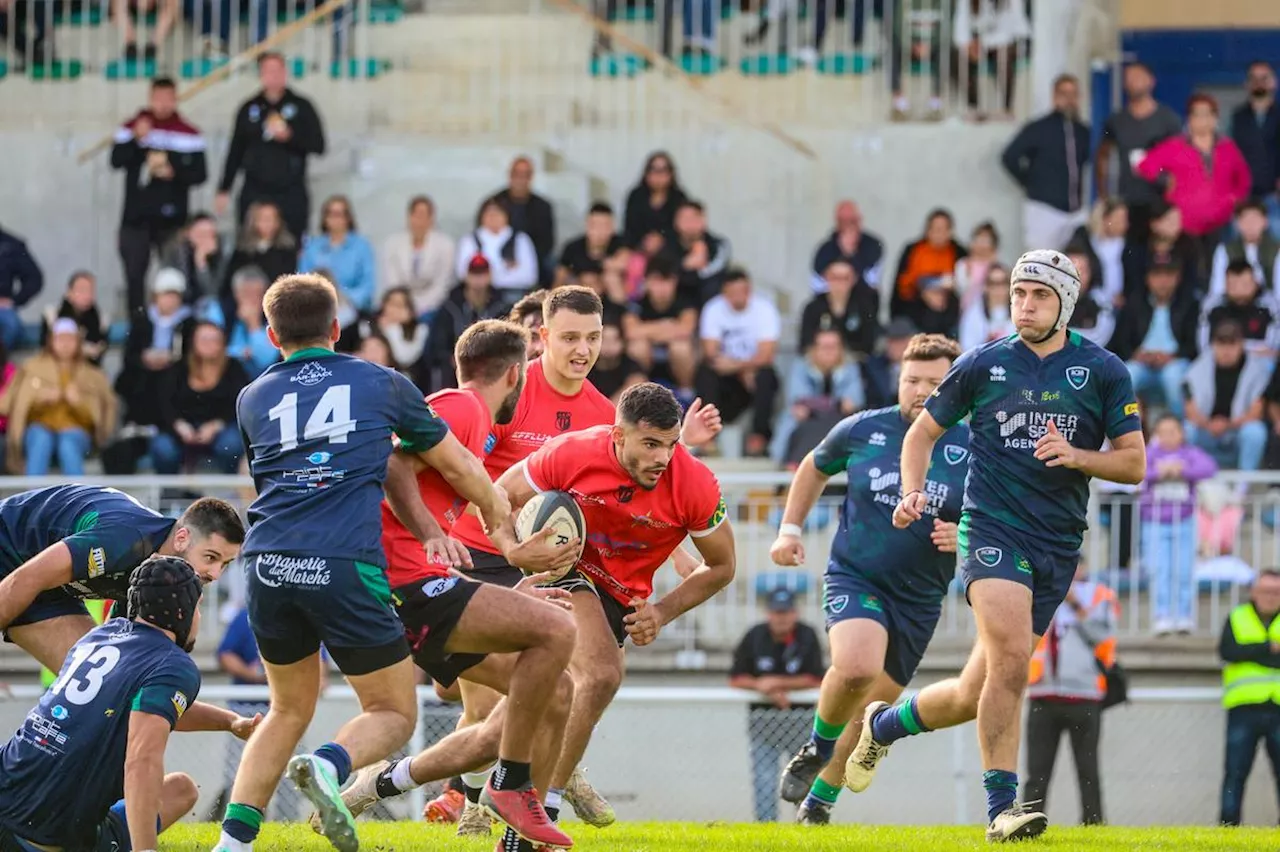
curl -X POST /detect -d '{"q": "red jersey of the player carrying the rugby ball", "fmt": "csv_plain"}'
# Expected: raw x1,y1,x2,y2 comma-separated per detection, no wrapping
525,426,726,604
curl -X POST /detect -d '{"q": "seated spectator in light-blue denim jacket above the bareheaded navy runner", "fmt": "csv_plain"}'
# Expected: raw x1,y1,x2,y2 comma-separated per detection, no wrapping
769,329,867,469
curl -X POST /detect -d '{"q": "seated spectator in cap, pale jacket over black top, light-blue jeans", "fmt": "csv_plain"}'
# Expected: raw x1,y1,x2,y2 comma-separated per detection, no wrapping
1183,320,1271,471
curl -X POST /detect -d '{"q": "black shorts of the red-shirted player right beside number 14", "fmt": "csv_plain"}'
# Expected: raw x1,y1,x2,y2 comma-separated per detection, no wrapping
392,577,488,687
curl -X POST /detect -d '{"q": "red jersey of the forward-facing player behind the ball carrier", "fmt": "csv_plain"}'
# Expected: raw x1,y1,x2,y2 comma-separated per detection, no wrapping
453,358,613,553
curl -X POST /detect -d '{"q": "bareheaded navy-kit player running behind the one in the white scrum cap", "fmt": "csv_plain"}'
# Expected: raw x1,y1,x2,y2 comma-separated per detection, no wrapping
769,334,969,824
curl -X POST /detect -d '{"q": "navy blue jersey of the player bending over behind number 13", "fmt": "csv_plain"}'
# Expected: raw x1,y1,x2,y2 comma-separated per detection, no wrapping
0,485,177,600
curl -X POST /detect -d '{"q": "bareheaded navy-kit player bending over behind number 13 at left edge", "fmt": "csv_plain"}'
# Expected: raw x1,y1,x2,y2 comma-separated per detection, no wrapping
0,485,256,739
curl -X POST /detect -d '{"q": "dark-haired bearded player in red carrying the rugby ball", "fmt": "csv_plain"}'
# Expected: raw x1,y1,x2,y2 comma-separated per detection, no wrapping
498,381,735,852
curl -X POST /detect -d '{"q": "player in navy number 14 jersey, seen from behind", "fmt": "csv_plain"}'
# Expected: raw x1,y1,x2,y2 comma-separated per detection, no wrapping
216,275,509,852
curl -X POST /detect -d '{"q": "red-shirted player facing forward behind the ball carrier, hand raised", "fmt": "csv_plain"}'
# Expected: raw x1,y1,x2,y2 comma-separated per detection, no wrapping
453,287,721,834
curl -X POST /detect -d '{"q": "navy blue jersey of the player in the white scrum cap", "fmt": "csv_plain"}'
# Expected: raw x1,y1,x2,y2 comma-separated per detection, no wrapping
925,331,1142,550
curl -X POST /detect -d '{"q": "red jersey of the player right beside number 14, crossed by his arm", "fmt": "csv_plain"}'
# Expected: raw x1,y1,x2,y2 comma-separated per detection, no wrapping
383,389,493,588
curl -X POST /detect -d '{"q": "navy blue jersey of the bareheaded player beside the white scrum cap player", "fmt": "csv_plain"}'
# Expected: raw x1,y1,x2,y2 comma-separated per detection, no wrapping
813,406,969,606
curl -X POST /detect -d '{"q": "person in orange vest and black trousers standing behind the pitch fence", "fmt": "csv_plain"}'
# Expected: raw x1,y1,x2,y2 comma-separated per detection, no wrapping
1023,559,1120,825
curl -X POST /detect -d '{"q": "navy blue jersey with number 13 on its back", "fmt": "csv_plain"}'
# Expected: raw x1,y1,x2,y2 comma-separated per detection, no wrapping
0,618,200,847
